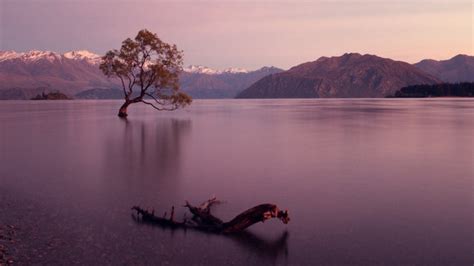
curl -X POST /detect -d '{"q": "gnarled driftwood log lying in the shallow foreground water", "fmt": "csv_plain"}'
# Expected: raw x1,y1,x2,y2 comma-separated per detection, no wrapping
132,198,290,233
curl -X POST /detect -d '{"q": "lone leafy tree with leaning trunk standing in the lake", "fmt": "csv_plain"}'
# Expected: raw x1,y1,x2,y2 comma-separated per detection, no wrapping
100,29,192,117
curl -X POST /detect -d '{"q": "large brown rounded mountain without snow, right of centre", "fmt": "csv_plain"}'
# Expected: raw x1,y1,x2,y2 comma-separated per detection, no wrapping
237,53,441,98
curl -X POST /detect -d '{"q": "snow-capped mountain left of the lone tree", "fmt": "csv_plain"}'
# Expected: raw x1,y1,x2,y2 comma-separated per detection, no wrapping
0,50,118,99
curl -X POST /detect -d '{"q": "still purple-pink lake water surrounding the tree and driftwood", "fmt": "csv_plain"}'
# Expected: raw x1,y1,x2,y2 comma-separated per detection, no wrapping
0,98,474,265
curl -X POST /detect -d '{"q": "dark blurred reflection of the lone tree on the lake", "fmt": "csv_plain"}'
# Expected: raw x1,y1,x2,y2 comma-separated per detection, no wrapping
103,118,192,192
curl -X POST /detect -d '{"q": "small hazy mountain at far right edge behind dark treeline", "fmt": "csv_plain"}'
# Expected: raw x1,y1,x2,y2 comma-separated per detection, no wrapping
414,54,474,82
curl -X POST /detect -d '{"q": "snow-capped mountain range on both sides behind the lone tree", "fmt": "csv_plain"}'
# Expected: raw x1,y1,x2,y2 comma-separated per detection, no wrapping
0,50,282,99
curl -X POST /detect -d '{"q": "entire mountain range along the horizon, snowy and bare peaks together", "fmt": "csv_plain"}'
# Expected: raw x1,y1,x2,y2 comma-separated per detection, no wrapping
0,50,474,99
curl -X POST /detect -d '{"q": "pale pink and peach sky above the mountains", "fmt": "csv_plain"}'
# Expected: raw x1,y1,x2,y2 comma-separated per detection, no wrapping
0,0,474,69
